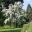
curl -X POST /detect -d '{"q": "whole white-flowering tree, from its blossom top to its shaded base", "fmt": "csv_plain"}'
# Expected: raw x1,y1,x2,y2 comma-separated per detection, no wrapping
2,1,26,27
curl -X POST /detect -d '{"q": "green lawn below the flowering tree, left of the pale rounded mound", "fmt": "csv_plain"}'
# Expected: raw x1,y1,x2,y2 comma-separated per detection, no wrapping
0,26,21,32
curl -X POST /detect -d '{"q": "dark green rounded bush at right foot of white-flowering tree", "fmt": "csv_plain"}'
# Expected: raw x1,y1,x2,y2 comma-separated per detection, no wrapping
16,16,29,28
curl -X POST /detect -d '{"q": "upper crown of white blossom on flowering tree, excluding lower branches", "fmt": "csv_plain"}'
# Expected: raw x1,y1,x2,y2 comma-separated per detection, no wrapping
2,2,22,23
